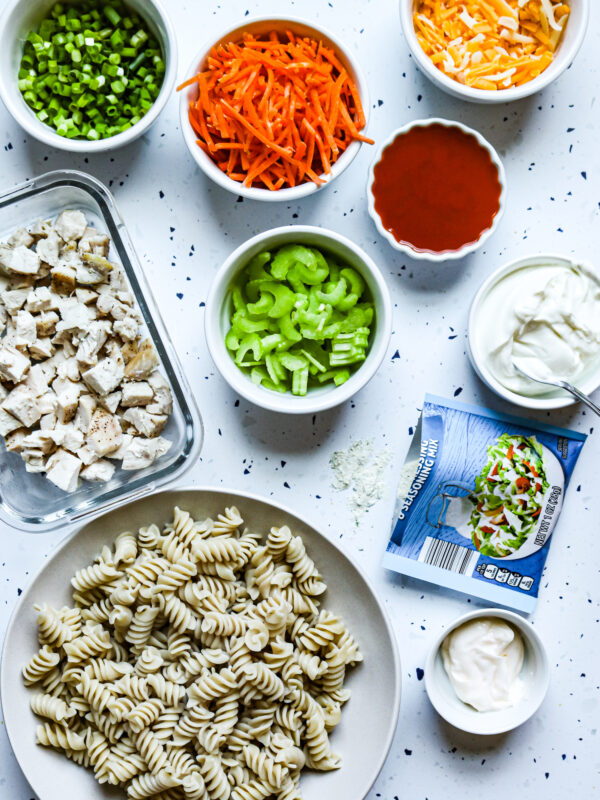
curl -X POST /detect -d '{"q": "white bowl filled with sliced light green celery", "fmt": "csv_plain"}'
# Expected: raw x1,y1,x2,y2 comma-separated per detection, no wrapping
205,225,392,414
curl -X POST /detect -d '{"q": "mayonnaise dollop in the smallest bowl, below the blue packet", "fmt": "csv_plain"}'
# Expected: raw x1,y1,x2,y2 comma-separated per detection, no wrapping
441,617,523,711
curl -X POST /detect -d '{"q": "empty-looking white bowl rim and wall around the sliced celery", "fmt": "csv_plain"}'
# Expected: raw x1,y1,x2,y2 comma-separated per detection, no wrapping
204,225,392,414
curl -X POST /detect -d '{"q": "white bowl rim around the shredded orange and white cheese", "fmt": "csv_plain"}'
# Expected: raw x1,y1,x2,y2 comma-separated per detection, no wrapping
399,0,590,103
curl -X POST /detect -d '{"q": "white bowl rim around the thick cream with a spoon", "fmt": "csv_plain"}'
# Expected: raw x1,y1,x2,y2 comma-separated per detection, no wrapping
467,253,600,411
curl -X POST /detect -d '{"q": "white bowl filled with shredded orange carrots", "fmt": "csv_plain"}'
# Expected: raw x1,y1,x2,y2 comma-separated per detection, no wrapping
179,17,372,201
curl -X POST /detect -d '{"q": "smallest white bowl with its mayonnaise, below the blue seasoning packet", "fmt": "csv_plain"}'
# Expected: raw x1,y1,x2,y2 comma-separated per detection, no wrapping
425,608,550,735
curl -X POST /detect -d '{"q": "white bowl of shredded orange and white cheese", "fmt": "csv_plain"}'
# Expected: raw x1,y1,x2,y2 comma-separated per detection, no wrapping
400,0,589,103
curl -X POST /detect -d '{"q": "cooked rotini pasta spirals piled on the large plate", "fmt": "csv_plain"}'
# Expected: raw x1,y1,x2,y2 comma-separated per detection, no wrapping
23,506,362,800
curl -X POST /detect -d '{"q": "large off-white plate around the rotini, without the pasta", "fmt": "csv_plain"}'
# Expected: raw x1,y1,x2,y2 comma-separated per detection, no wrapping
0,489,401,800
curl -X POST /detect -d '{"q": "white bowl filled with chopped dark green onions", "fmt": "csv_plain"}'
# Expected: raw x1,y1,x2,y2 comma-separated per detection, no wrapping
0,0,177,153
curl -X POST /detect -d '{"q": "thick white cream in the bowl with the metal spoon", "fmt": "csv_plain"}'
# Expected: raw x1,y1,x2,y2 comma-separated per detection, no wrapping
474,259,600,396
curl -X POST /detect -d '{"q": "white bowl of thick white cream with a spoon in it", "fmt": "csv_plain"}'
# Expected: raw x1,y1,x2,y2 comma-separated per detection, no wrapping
469,254,600,410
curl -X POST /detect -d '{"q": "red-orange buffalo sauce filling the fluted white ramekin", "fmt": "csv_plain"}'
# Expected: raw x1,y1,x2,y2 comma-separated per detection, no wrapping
373,123,502,253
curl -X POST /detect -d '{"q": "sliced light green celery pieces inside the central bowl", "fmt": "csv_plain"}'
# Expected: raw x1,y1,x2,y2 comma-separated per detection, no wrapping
225,244,374,395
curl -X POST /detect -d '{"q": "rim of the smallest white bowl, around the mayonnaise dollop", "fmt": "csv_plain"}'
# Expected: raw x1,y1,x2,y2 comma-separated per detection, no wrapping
425,607,550,736
